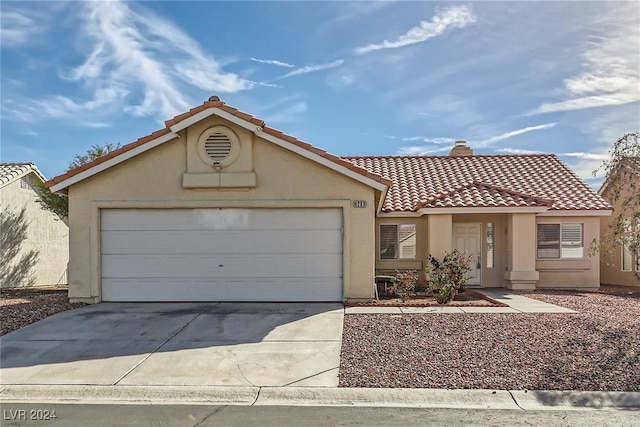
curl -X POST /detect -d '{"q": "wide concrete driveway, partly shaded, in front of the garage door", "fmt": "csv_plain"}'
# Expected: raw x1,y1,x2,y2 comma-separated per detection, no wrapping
0,303,344,387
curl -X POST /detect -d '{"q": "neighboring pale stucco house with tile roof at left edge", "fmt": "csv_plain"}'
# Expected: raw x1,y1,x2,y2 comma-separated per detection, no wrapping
0,163,69,289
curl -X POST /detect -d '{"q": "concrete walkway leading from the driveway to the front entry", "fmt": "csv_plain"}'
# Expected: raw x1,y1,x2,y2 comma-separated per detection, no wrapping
345,288,577,314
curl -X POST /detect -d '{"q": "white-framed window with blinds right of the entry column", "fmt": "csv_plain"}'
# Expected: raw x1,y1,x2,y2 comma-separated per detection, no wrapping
538,224,584,259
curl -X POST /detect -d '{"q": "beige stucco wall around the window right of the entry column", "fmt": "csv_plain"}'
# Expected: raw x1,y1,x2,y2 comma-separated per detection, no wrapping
536,216,601,288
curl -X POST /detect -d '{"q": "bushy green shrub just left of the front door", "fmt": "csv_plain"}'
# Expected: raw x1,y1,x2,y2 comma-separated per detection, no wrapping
425,250,472,304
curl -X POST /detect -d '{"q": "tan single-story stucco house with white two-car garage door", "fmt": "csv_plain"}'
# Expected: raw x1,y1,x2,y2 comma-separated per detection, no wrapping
47,97,611,303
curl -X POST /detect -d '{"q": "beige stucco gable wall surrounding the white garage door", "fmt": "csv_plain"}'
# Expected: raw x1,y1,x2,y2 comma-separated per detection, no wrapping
69,117,375,302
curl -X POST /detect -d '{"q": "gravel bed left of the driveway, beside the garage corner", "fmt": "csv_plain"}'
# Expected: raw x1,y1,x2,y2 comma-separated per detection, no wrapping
0,289,84,335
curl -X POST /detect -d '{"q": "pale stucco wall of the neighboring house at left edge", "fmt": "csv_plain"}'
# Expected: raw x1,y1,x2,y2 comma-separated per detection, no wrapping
0,173,69,288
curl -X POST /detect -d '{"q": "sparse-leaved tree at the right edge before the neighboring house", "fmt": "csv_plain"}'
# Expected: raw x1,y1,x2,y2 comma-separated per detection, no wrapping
589,132,640,270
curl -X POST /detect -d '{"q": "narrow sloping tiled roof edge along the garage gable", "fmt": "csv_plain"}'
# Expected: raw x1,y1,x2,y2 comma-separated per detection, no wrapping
46,97,391,187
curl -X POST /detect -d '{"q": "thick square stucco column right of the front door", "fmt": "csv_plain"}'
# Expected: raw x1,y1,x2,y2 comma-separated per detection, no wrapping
504,213,540,289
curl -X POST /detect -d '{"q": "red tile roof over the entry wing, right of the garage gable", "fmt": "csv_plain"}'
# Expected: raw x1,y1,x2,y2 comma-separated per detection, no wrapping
343,154,611,212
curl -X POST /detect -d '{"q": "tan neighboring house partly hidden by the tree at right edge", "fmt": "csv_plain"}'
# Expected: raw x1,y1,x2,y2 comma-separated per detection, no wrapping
598,157,640,286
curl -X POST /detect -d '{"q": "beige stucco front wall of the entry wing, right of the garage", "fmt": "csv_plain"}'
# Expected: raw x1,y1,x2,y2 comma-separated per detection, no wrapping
376,213,600,289
